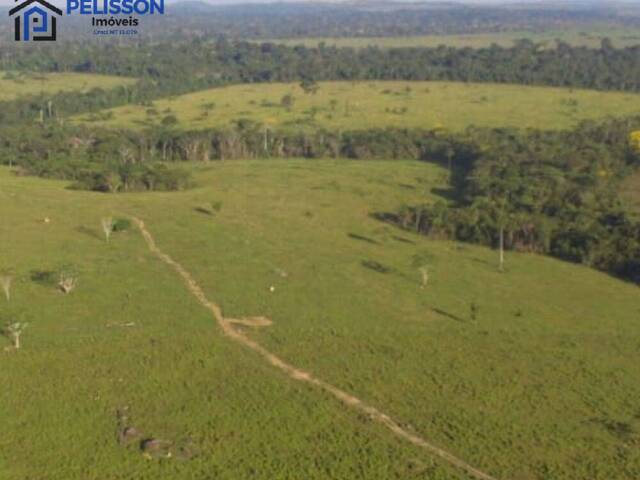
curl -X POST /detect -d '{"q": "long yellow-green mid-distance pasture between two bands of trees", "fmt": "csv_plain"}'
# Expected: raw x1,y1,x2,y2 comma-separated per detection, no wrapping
74,82,640,131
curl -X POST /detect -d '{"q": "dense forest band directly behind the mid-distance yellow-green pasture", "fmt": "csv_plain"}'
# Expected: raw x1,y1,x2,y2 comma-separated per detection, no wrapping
0,39,640,126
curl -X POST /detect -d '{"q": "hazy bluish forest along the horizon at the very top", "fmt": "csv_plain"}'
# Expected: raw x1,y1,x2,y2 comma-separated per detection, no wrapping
0,1,640,42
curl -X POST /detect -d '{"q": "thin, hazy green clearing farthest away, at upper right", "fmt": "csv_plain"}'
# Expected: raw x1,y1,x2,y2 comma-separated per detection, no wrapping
260,27,640,48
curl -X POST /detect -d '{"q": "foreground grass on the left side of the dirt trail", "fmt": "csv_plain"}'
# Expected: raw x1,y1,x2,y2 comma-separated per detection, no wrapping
0,166,455,480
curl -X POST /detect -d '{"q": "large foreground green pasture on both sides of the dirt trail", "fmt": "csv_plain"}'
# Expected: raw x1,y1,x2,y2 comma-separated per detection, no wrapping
0,160,640,480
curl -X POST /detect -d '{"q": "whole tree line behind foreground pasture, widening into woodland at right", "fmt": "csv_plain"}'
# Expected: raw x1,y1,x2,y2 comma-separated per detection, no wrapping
0,98,640,282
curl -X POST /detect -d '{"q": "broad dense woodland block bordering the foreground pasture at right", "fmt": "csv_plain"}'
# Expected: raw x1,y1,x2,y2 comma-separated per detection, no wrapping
378,117,640,283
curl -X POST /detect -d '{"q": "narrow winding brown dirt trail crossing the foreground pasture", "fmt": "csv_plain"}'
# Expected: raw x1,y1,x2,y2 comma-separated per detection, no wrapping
133,217,497,480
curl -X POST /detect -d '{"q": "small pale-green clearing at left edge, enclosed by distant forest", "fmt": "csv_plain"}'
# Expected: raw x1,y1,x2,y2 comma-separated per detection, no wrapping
0,71,135,101
